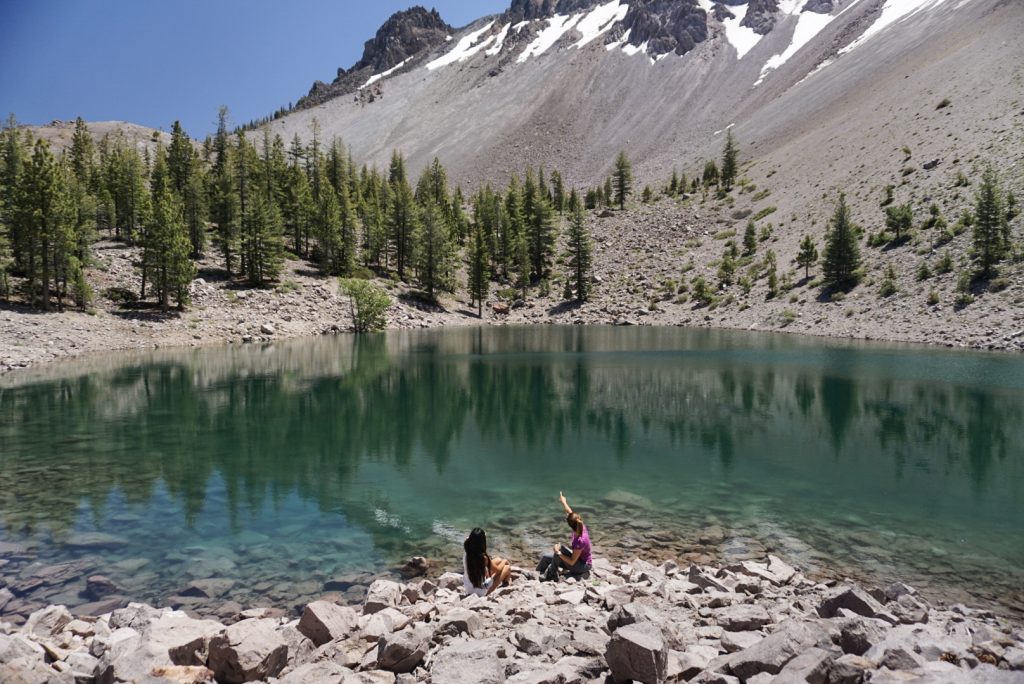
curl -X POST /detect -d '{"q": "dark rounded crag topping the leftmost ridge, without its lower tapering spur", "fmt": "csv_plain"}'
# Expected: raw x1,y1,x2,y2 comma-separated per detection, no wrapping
351,5,453,73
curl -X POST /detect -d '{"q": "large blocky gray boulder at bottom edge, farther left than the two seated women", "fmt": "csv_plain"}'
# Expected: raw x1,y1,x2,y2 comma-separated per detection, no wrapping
209,619,288,684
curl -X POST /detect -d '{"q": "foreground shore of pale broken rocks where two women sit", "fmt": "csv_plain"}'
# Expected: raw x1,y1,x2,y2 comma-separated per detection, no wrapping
0,556,1024,684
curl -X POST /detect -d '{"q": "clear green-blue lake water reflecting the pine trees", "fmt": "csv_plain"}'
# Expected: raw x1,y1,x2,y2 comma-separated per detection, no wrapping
0,327,1024,613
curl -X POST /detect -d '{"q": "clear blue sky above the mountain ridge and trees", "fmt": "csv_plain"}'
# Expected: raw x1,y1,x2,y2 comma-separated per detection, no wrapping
0,0,510,137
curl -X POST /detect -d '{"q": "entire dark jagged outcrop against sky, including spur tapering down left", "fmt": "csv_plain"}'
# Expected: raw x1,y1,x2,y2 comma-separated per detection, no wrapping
296,5,454,109
